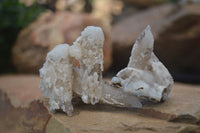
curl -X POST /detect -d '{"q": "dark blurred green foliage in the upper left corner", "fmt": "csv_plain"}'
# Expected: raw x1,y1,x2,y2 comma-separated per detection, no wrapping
0,0,45,73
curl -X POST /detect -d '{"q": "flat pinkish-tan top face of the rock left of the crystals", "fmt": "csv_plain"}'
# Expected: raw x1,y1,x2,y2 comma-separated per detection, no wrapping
0,75,42,107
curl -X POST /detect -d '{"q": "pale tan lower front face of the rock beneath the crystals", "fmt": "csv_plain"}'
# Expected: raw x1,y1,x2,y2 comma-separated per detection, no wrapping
50,106,197,133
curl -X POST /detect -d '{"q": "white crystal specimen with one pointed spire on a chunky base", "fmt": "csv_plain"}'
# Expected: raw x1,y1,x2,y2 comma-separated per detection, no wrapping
111,26,174,102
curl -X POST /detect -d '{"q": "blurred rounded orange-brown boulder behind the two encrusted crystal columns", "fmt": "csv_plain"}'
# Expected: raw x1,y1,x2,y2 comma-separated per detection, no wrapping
13,11,111,73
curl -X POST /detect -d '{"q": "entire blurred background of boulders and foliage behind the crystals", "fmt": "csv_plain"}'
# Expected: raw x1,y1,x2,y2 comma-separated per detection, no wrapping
0,0,200,83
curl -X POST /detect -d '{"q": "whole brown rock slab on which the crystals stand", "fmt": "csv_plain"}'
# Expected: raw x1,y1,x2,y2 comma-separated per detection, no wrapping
0,75,200,133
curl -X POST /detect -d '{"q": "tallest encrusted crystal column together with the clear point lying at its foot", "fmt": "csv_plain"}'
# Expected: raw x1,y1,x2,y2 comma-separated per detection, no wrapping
73,26,142,108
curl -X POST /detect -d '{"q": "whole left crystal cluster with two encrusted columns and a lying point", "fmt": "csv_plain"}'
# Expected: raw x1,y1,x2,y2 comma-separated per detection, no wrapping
40,26,142,116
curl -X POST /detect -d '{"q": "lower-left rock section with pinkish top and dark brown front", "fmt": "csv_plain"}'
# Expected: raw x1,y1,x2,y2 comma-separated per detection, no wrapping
0,76,51,133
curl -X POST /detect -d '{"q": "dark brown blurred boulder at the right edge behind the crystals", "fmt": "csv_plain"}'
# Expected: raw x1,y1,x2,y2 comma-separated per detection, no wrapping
155,5,200,77
